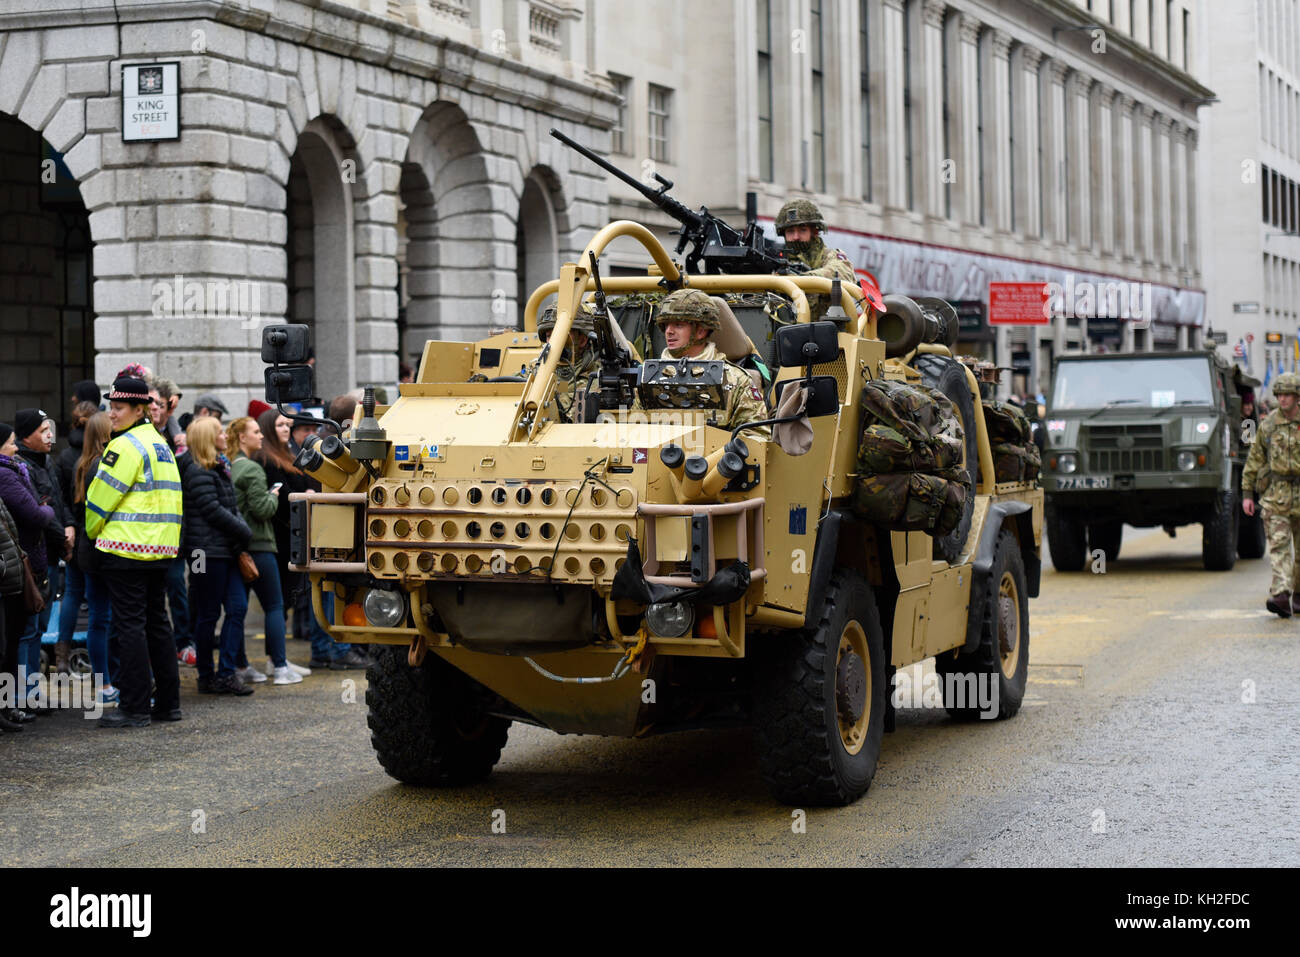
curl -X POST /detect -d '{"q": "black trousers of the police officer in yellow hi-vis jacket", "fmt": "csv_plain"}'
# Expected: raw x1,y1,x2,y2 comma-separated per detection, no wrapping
100,554,181,714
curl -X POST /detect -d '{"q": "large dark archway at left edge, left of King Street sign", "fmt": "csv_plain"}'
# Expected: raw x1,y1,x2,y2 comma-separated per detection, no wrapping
0,113,95,428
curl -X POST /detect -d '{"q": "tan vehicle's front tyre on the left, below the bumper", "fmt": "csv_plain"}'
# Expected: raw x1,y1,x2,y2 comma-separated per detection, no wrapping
365,645,510,787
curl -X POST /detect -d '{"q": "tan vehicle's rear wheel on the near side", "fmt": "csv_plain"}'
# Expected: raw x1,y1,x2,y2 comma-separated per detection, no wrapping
935,529,1030,720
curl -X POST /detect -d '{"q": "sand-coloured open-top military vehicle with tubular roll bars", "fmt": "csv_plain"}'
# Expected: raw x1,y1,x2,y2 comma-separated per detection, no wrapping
264,221,1043,805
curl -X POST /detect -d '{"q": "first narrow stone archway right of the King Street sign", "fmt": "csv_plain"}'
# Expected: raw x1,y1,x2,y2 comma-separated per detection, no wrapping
285,117,356,402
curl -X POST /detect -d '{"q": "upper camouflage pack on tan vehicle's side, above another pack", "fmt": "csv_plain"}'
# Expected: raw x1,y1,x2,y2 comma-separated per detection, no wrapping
858,380,963,475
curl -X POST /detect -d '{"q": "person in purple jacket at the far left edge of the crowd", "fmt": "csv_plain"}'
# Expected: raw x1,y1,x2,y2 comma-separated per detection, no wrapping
0,425,57,720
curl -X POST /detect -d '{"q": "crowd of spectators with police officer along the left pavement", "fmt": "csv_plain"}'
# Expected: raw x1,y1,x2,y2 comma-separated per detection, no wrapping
0,363,369,732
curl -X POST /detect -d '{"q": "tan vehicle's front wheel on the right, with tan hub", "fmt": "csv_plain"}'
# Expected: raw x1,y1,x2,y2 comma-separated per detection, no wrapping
751,568,888,805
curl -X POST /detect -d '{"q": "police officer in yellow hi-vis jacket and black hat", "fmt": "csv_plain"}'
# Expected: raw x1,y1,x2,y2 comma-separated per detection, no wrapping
86,376,182,728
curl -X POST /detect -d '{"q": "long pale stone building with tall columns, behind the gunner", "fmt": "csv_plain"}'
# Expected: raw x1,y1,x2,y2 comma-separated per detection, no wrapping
597,0,1217,391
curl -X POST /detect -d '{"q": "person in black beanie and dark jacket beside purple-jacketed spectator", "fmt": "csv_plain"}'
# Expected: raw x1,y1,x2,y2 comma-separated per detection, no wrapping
13,408,77,675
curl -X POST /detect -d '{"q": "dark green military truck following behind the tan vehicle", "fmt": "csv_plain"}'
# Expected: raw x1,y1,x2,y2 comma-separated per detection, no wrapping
1043,350,1265,571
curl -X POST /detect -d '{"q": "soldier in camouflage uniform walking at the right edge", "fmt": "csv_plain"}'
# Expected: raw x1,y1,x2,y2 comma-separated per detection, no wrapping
1242,372,1300,618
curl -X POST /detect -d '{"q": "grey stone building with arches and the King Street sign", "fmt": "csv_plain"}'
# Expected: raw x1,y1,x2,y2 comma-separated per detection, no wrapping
0,0,616,417
